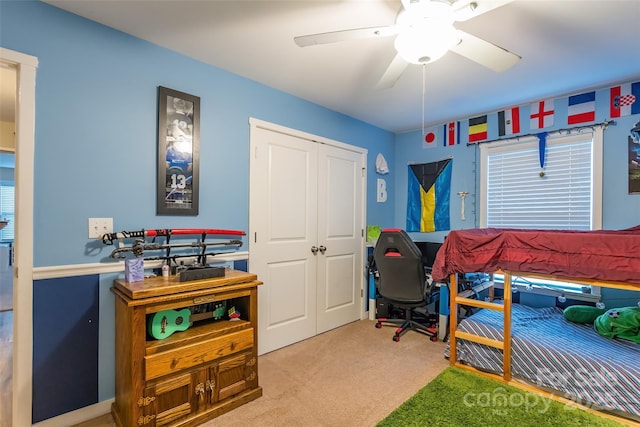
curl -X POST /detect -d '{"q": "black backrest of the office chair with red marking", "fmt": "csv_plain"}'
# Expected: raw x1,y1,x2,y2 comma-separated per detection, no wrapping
373,229,426,304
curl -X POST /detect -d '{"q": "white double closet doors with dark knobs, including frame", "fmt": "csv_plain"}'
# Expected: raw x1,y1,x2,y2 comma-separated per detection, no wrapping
249,120,366,354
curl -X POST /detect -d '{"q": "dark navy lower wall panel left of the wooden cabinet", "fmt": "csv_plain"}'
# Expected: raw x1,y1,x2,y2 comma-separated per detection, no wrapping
33,275,99,423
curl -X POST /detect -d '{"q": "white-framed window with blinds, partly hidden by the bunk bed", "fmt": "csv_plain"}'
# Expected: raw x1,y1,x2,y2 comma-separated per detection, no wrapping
480,127,602,300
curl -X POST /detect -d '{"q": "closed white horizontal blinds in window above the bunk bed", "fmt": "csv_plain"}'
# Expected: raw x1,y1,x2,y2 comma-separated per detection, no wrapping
486,134,593,230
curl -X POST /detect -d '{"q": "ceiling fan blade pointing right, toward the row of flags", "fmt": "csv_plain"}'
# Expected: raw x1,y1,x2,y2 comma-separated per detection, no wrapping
450,30,521,72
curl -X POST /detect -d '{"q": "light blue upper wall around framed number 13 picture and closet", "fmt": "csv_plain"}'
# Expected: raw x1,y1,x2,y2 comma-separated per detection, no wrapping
0,1,394,267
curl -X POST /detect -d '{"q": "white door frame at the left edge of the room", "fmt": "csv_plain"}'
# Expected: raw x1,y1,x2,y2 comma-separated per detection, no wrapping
0,48,38,426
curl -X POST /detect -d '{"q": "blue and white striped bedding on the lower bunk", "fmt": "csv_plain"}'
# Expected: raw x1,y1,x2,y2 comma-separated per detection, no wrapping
445,304,640,416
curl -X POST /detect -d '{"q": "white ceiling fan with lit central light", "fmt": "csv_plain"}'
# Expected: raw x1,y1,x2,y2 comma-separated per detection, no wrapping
294,0,521,89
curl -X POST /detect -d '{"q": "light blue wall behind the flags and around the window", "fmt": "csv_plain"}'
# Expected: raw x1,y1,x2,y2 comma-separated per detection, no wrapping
394,91,640,241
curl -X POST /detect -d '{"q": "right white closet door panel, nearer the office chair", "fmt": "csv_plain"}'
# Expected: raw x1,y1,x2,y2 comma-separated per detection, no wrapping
316,144,364,333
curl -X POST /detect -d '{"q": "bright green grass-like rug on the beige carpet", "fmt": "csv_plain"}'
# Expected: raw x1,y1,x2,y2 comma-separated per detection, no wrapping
378,367,622,427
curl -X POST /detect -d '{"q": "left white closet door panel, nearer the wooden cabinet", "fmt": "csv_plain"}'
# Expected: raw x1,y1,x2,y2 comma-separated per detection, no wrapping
249,128,318,354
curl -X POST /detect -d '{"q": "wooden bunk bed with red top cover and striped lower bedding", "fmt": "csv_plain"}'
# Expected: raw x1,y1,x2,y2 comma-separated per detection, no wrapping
431,226,640,421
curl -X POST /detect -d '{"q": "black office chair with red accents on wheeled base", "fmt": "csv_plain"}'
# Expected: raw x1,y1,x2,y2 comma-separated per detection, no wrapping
373,229,438,342
